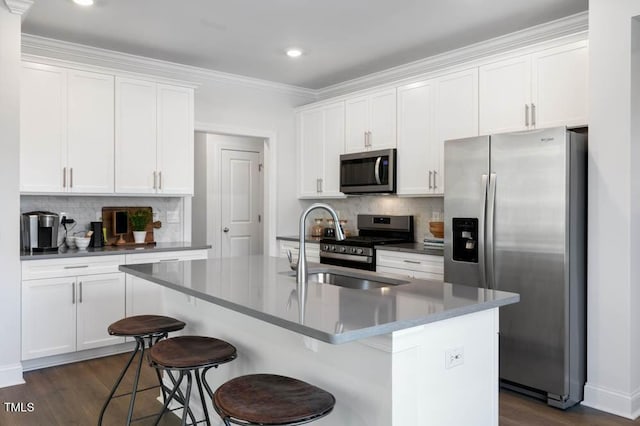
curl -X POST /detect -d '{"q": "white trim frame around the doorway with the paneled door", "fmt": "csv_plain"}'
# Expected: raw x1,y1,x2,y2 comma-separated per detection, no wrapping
194,122,278,257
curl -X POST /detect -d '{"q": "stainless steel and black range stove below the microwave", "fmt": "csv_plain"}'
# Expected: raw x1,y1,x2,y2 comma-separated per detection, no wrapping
320,214,414,271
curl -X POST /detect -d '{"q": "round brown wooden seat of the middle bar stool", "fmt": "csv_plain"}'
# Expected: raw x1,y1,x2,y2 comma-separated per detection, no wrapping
148,336,237,368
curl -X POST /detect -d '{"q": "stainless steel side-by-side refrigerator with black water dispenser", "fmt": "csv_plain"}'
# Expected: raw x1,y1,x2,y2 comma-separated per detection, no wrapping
444,127,586,408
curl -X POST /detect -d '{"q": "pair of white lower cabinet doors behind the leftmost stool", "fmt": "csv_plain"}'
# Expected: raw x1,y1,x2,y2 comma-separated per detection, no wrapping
22,270,125,360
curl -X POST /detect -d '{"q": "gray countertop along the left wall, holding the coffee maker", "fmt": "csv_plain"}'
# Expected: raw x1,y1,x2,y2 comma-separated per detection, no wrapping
20,242,211,260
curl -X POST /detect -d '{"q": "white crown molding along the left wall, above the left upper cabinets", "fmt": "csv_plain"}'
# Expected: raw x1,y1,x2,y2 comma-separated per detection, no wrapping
20,33,318,99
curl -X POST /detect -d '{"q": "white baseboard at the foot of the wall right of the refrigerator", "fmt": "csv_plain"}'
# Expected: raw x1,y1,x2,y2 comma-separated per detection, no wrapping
582,383,640,420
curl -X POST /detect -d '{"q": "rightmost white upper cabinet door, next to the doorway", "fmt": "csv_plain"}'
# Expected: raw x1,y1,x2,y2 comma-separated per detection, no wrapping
157,84,194,195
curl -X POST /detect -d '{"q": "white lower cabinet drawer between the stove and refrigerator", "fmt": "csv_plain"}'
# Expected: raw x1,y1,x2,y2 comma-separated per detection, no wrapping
376,250,444,280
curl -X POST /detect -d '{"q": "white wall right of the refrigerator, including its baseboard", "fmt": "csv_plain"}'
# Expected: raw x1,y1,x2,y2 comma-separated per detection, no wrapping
584,0,640,418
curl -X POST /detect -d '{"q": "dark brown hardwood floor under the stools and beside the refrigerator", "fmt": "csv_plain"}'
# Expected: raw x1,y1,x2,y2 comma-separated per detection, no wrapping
0,354,640,426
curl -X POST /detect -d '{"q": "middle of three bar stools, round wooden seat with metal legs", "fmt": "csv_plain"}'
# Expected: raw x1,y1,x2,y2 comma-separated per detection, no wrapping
149,336,237,425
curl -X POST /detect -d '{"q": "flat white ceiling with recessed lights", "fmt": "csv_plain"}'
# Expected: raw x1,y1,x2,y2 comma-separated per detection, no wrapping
22,0,588,89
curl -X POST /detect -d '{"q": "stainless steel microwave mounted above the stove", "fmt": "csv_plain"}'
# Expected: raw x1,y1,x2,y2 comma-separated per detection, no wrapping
340,148,396,194
